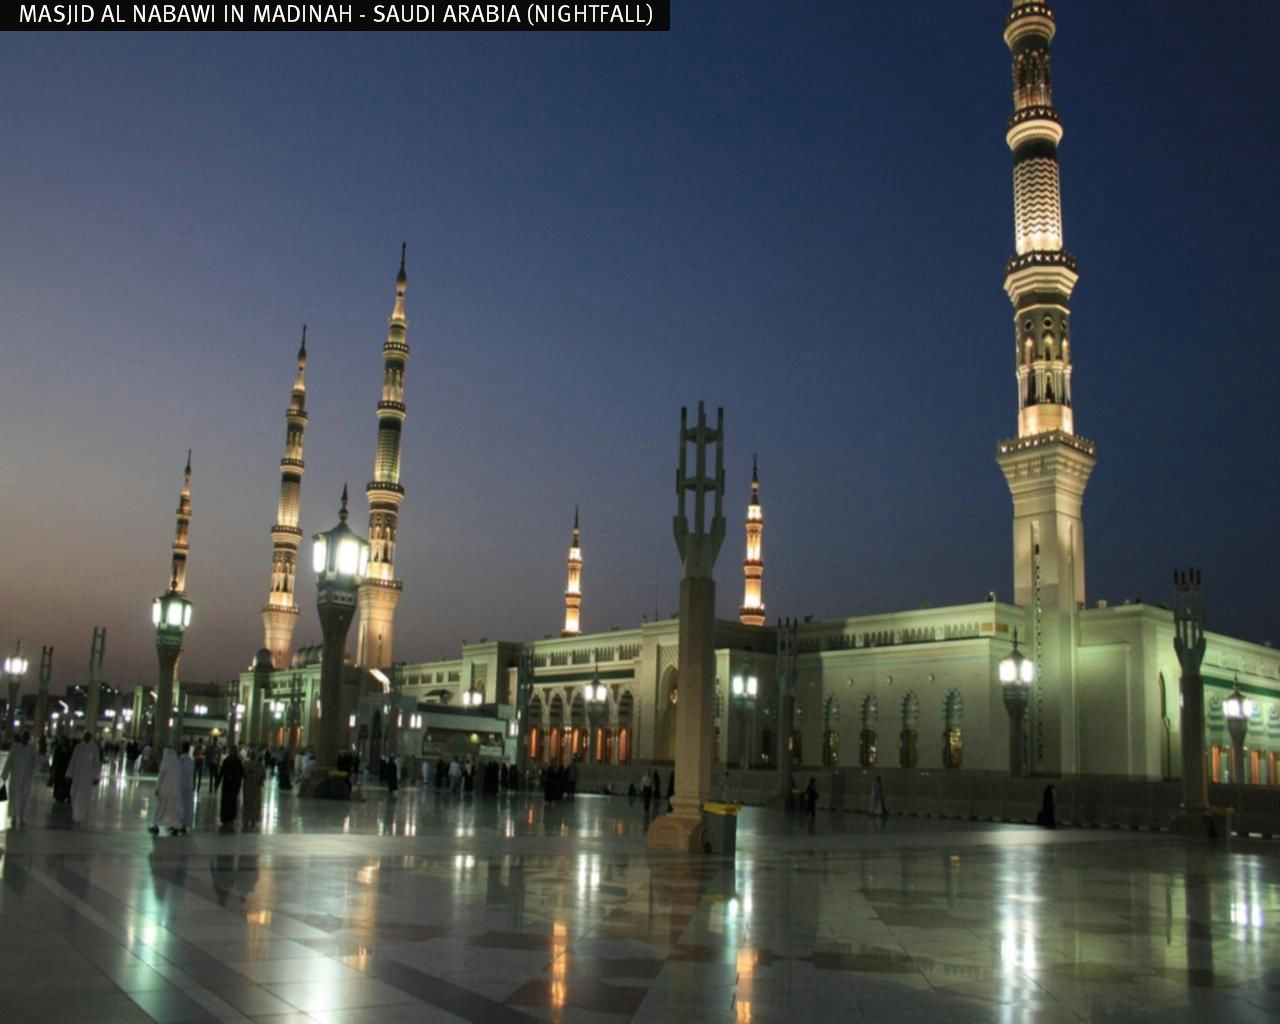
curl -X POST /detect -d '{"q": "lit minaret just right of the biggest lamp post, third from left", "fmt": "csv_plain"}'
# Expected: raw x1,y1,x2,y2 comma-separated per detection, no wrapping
356,244,408,668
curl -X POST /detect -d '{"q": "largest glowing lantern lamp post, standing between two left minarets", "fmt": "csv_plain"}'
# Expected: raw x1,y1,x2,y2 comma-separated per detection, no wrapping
312,486,369,778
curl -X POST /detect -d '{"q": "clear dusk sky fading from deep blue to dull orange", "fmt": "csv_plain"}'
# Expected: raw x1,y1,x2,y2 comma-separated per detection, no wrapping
0,0,1280,691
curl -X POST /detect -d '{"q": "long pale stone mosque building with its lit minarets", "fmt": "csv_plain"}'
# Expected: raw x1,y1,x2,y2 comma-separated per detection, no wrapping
241,0,1280,785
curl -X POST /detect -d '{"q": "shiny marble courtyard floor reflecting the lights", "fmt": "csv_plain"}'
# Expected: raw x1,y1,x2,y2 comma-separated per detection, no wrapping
0,778,1280,1024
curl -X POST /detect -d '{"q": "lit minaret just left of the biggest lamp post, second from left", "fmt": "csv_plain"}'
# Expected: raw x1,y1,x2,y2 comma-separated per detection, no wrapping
262,324,307,668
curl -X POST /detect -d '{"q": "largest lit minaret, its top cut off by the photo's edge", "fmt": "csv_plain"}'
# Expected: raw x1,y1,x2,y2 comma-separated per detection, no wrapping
997,0,1094,772
